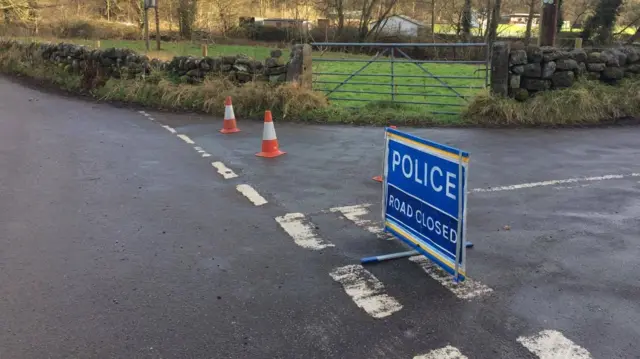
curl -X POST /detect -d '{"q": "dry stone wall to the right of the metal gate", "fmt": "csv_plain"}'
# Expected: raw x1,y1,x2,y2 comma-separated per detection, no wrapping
508,46,640,101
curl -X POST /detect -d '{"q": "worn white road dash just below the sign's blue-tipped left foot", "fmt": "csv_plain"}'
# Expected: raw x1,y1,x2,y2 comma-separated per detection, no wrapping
330,264,402,318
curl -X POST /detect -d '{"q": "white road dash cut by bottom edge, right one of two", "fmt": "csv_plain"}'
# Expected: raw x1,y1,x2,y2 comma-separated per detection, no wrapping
517,330,592,359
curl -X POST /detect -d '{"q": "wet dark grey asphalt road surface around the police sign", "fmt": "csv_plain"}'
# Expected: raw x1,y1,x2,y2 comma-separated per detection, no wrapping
0,79,640,359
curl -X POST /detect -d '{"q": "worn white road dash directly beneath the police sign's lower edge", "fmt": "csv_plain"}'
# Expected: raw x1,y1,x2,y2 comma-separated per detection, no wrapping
409,256,493,300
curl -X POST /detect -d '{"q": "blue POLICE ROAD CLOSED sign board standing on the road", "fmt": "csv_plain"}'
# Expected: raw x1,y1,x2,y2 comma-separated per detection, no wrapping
383,128,469,280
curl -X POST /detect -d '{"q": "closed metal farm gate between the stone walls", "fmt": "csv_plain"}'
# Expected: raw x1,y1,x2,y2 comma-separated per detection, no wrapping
311,42,490,115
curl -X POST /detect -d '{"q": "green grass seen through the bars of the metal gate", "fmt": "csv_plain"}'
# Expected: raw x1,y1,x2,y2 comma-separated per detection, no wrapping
313,53,486,113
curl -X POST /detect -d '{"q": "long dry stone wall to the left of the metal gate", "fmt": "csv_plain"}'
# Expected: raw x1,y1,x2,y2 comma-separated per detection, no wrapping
0,40,303,84
